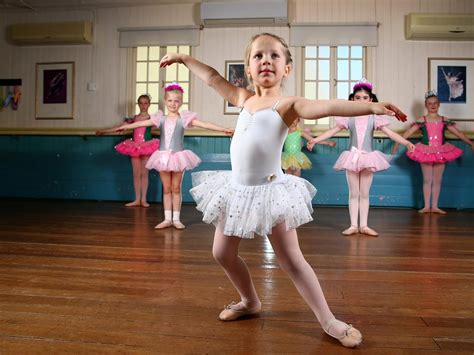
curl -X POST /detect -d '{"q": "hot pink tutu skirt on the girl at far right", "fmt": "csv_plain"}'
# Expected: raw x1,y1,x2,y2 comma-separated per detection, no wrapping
407,143,462,164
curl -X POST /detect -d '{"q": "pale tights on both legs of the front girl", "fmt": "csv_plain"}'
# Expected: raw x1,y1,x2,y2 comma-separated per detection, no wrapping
212,223,346,335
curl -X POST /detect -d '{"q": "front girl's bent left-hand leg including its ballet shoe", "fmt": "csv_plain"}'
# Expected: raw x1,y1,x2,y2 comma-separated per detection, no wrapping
212,225,261,320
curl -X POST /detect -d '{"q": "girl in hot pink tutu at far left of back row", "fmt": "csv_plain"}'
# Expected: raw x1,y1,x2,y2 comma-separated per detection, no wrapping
96,95,160,207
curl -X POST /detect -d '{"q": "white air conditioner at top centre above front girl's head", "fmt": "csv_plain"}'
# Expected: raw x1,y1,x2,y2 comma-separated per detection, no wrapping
201,0,288,27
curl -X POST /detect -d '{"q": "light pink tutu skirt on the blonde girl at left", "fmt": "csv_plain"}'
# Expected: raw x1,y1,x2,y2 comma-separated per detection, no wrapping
146,150,201,171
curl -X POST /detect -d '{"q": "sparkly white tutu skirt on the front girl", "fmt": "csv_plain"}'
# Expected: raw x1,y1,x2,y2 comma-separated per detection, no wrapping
190,171,316,238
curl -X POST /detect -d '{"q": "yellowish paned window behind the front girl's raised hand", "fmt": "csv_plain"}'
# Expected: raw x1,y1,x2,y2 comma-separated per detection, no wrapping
134,46,191,114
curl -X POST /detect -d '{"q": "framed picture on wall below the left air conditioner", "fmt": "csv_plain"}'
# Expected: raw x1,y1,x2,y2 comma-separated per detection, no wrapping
35,62,74,119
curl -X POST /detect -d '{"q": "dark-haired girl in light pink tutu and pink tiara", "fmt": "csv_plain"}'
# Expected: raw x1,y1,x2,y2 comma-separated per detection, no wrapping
307,79,415,237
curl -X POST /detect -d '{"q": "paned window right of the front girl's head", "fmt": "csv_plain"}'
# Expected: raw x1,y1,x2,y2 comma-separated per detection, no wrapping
303,46,366,125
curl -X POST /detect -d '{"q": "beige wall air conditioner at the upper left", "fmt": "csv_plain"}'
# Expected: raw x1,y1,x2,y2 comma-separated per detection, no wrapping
8,21,92,46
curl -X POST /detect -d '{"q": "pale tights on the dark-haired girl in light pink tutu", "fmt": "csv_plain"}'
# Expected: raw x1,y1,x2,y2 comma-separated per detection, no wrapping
346,169,374,227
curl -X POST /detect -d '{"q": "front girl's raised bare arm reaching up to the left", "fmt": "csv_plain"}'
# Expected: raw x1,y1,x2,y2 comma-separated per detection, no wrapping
160,53,253,107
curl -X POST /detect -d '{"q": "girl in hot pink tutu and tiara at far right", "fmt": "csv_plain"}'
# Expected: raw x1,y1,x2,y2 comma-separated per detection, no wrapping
392,91,474,214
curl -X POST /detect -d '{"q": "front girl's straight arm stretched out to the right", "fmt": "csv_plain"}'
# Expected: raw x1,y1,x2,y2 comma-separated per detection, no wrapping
287,98,406,124
